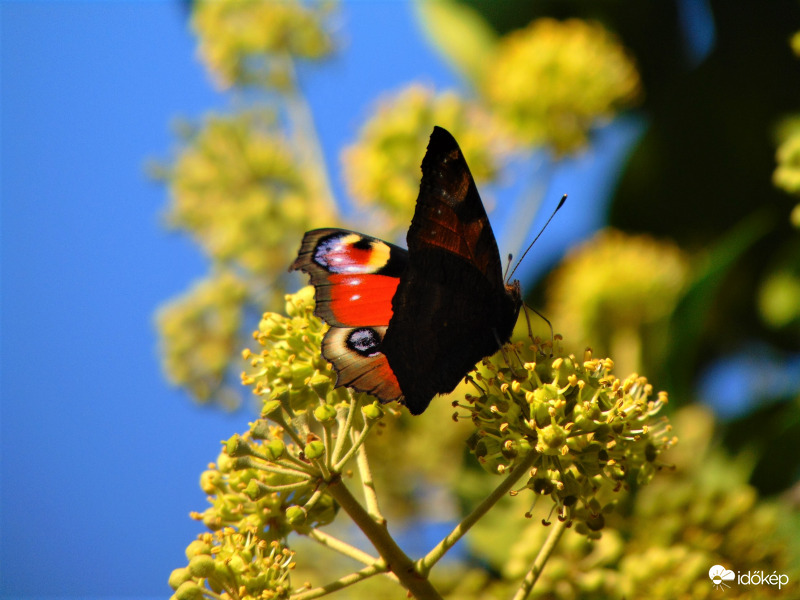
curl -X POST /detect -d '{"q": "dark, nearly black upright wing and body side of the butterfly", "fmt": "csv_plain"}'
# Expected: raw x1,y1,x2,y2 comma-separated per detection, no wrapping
382,127,522,414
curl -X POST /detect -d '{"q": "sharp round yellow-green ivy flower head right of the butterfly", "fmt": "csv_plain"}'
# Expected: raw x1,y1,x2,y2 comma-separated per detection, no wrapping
462,344,675,535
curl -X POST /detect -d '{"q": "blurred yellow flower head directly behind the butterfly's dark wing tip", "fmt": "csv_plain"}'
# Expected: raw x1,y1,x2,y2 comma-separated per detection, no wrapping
342,85,498,232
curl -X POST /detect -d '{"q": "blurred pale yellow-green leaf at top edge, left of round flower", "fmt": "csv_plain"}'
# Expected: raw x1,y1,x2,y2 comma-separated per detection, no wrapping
414,0,497,87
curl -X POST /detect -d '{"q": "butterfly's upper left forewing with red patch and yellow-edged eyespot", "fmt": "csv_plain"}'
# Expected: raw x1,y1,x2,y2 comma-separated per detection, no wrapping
291,229,408,327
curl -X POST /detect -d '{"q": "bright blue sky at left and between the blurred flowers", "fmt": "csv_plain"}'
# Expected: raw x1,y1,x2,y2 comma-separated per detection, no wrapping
0,1,640,598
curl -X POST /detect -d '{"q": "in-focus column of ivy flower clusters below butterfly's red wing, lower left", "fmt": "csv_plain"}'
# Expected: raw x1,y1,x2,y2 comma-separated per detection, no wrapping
170,287,384,600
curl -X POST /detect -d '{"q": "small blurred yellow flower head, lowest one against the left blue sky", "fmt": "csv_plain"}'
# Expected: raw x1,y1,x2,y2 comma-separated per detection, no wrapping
157,271,247,407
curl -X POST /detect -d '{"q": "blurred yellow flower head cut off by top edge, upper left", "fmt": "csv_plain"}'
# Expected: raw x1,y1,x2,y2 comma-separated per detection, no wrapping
192,0,332,90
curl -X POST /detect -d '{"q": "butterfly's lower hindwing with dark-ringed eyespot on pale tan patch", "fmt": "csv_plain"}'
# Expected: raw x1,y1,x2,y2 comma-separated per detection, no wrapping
322,327,403,402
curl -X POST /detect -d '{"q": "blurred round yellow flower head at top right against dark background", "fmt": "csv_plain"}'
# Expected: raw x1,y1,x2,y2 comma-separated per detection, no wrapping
484,18,641,154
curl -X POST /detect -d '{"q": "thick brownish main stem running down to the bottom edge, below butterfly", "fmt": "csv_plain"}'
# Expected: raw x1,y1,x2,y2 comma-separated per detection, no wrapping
328,477,442,600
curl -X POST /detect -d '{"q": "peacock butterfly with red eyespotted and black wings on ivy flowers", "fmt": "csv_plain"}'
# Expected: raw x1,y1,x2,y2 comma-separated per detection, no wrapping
290,127,522,415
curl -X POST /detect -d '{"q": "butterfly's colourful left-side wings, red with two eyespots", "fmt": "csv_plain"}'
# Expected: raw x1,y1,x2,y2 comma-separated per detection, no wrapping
290,229,408,402
